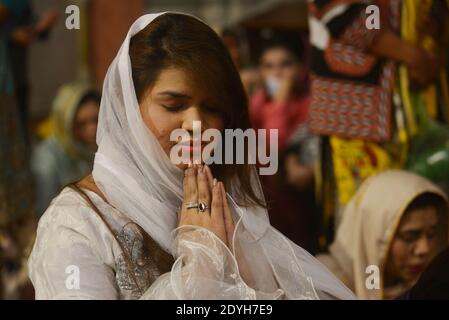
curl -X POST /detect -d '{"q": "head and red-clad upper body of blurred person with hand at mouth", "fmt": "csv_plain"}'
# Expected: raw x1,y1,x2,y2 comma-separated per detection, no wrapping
250,36,309,150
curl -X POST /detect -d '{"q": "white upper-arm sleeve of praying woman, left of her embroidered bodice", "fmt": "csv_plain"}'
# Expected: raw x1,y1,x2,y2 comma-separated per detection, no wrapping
29,226,118,300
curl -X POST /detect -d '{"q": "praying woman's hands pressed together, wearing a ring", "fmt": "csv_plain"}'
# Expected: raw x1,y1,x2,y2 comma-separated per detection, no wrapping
179,165,234,248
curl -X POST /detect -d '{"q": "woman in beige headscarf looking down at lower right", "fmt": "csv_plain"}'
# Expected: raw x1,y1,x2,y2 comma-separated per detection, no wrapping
318,170,448,299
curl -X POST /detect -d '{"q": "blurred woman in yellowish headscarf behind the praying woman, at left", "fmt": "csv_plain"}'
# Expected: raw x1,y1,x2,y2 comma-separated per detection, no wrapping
31,83,100,215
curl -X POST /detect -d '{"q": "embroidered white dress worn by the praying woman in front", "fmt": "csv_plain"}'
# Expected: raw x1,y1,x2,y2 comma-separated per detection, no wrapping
29,187,282,299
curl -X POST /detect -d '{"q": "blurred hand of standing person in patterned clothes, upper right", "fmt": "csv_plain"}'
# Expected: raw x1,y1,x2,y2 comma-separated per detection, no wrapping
406,46,439,89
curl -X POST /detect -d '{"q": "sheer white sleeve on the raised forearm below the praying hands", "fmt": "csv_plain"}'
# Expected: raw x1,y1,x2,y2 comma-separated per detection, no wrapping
141,226,283,300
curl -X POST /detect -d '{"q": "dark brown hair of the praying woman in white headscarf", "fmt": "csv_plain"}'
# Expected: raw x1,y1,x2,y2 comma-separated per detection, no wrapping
129,13,265,206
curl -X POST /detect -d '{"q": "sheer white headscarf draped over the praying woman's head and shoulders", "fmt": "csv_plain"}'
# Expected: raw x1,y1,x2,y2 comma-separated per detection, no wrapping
93,13,354,299
